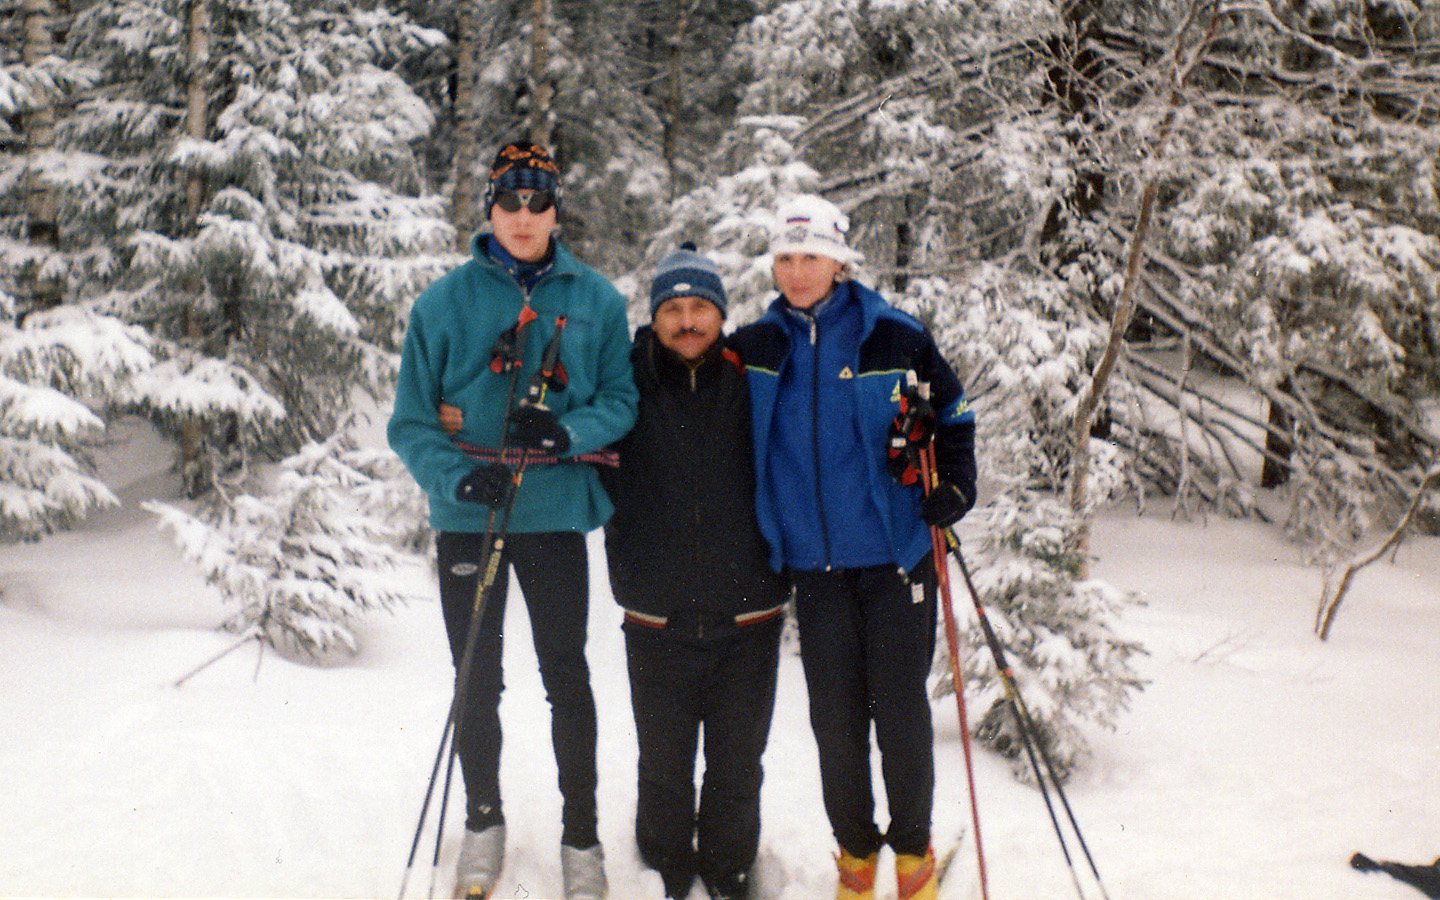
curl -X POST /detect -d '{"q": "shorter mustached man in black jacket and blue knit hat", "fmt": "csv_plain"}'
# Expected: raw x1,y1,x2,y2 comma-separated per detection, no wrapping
605,245,788,900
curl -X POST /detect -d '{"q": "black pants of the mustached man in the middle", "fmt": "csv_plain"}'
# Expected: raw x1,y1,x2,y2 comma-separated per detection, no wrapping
625,619,780,877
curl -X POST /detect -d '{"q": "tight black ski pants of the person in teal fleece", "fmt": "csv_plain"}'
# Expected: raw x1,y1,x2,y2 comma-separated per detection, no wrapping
436,531,599,850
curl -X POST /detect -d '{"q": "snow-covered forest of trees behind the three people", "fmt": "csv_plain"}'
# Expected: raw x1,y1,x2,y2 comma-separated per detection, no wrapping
0,0,1440,765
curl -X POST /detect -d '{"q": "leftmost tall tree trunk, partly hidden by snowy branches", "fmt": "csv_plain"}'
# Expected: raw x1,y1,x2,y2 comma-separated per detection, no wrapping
22,0,62,310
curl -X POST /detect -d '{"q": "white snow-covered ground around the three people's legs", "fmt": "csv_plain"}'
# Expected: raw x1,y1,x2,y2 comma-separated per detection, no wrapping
0,428,1440,900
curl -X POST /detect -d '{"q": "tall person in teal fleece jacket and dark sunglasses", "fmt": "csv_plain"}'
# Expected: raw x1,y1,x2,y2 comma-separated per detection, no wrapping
389,143,636,900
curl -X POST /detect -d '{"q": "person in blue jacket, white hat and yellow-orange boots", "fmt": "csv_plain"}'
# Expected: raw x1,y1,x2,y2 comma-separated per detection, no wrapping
733,197,975,900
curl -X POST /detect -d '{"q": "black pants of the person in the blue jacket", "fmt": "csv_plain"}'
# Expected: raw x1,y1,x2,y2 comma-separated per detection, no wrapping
791,556,936,857
